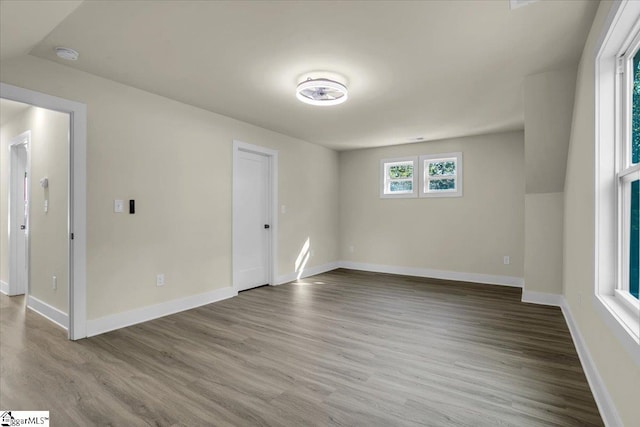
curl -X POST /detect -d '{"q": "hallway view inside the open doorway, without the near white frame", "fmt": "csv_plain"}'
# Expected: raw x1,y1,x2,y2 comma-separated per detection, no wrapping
0,99,70,329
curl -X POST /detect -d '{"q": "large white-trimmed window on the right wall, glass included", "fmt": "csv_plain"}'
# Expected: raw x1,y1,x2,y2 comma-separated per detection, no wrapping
594,1,640,354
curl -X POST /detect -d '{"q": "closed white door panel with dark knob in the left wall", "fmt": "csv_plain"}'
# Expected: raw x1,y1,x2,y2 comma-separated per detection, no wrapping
234,150,271,291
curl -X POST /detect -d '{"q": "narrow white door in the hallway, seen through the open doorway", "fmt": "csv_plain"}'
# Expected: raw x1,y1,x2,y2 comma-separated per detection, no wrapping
9,137,30,295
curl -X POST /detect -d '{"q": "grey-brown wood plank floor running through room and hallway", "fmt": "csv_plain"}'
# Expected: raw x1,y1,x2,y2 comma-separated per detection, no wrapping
0,270,603,427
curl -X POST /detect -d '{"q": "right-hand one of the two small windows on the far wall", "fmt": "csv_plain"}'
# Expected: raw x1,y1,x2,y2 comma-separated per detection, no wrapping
420,152,462,197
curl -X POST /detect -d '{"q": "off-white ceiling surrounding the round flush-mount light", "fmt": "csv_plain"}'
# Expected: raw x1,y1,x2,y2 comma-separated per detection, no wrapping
2,0,598,150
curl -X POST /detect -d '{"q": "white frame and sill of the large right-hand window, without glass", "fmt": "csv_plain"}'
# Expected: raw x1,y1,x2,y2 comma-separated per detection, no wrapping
593,1,640,365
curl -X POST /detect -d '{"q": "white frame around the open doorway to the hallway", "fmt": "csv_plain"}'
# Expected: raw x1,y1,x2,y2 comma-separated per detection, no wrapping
0,82,87,340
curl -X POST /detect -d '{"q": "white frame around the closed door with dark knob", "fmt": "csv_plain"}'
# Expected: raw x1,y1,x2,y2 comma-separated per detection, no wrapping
231,140,278,292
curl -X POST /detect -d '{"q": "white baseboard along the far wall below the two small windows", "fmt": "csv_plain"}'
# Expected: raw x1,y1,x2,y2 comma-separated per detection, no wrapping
338,261,524,288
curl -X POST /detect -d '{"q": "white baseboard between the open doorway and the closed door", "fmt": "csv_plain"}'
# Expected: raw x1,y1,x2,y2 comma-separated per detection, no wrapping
87,287,238,337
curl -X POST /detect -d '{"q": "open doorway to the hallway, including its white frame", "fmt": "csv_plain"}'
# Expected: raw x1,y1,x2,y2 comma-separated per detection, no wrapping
0,83,87,340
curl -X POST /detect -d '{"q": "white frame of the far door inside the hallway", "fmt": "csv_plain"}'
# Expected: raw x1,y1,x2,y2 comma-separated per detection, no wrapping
7,130,31,295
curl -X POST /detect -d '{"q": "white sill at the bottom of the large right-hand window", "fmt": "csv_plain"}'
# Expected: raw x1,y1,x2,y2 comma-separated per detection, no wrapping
594,295,640,366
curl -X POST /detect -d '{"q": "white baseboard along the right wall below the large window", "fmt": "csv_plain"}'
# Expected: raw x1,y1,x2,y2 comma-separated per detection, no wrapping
560,296,622,427
